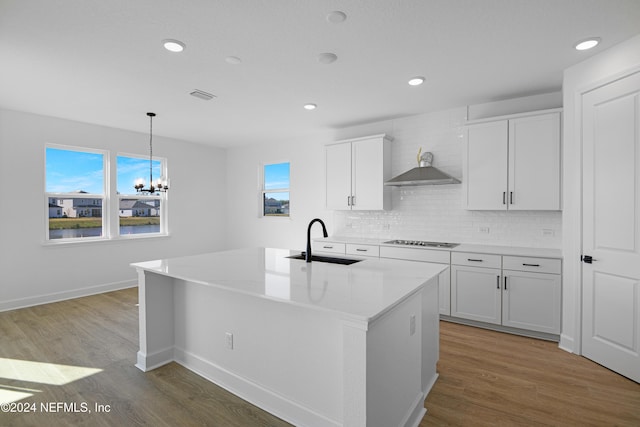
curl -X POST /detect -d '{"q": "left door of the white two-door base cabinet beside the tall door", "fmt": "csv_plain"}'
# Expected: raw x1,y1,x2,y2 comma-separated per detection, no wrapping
451,265,502,325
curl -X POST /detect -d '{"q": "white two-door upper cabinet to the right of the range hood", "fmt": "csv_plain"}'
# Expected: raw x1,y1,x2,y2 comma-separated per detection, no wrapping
463,109,561,210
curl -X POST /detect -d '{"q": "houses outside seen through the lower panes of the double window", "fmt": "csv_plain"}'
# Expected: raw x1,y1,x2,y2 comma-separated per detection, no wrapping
49,191,160,218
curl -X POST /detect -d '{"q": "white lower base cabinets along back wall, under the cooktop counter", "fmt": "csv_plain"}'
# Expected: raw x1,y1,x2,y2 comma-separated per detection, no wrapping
313,240,562,340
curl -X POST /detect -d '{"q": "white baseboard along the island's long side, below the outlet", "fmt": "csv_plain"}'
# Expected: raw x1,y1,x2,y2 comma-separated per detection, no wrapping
174,348,342,427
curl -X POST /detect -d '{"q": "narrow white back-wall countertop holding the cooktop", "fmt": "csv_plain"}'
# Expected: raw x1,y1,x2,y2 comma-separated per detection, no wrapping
313,236,562,259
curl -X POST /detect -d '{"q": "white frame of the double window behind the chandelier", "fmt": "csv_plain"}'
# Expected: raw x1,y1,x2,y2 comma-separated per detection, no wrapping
43,143,169,245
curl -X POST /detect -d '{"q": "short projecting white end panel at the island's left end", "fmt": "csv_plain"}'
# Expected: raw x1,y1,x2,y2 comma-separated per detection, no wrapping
136,268,174,372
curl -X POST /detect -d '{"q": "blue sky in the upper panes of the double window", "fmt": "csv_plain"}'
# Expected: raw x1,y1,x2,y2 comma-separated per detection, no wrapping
46,148,161,194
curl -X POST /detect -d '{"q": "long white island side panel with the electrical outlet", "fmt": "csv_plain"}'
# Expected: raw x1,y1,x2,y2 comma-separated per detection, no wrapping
174,280,343,427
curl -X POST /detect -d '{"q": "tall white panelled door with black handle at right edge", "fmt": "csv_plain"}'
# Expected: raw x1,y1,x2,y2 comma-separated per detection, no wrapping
582,73,640,382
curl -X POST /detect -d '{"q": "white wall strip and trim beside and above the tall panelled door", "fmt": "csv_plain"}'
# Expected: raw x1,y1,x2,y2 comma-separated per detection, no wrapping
560,35,640,354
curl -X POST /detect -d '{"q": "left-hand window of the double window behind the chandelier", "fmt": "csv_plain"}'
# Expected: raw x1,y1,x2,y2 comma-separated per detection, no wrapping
45,147,106,240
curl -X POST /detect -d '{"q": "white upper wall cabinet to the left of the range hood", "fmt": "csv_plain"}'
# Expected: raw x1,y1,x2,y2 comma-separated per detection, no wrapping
325,134,391,210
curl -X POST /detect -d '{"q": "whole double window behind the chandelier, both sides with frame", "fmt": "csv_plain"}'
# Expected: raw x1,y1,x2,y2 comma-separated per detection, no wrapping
45,146,167,241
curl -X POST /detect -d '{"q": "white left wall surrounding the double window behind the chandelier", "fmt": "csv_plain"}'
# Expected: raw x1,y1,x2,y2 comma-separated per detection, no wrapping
0,110,227,311
